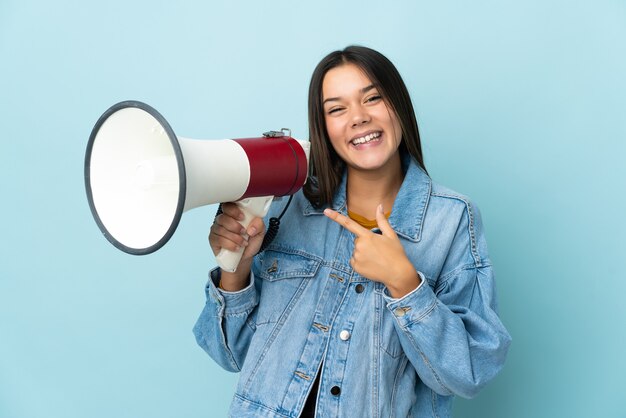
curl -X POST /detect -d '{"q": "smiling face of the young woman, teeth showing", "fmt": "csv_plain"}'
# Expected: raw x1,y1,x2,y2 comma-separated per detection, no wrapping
322,64,402,176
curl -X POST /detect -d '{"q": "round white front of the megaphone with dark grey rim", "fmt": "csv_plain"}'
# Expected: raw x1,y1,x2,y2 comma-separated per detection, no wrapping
85,101,186,255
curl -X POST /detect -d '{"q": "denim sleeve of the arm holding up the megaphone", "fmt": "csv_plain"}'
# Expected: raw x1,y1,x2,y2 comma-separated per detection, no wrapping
193,268,259,372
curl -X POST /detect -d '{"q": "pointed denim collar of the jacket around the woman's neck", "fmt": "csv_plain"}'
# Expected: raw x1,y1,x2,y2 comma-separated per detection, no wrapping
302,155,432,242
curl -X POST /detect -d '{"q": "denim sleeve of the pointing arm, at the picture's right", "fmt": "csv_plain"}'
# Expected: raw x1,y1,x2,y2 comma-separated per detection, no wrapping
385,203,511,398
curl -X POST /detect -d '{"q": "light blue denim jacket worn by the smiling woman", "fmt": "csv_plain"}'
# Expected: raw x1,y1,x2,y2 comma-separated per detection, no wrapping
194,157,510,418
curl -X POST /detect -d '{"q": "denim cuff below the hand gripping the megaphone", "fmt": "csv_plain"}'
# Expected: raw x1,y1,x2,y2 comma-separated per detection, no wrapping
206,267,258,315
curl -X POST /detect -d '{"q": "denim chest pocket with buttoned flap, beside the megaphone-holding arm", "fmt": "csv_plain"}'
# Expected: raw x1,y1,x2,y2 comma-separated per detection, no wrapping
255,250,322,325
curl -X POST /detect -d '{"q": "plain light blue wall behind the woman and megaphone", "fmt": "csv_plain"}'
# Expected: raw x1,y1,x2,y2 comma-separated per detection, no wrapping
0,0,626,418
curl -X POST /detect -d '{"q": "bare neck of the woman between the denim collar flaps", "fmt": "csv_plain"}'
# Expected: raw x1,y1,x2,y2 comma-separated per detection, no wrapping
346,154,404,219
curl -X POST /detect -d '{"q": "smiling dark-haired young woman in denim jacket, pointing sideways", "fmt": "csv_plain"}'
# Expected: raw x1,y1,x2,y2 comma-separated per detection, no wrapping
194,46,510,418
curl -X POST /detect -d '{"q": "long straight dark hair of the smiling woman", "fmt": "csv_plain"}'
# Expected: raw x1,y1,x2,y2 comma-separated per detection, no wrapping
304,45,426,207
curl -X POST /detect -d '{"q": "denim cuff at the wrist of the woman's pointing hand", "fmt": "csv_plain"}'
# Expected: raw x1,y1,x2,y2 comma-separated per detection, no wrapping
383,271,437,327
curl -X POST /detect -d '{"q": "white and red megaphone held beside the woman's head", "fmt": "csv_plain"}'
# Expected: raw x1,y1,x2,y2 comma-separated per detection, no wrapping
85,101,309,272
